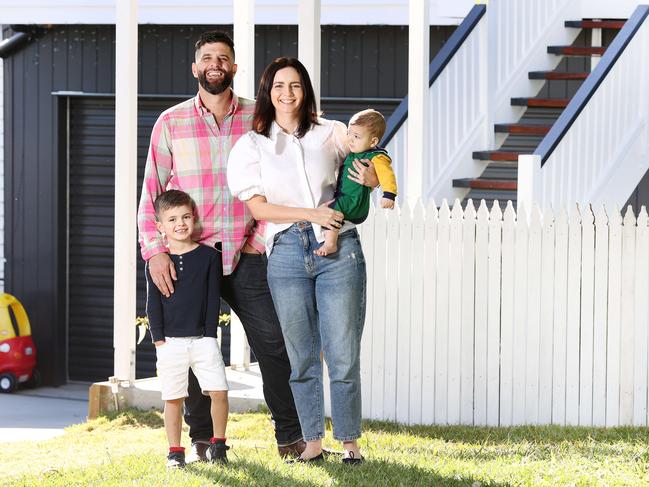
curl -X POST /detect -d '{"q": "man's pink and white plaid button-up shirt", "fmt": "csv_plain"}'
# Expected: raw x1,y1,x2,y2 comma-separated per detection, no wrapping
137,92,265,274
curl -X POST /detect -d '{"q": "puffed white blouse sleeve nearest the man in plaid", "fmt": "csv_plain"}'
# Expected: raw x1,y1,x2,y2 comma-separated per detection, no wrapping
228,132,266,201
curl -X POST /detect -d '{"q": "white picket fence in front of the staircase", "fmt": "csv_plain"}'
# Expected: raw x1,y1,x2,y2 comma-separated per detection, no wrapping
359,201,649,426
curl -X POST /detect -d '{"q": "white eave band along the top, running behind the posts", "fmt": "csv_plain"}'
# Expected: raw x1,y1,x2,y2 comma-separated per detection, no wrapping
0,0,468,25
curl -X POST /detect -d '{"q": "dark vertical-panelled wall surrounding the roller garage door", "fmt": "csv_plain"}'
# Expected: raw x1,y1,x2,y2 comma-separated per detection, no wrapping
3,25,453,384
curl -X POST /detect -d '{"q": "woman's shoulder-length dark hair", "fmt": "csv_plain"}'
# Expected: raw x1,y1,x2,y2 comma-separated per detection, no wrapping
252,57,318,141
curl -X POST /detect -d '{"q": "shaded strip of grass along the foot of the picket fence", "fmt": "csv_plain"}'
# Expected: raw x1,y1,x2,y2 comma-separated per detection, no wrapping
363,421,649,445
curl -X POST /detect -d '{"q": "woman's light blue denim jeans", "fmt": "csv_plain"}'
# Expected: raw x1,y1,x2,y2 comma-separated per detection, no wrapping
268,222,366,441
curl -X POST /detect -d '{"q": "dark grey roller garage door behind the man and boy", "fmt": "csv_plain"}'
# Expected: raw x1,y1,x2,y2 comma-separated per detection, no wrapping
68,97,229,381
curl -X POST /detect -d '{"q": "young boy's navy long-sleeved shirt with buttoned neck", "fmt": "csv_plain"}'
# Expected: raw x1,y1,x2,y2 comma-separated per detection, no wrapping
145,245,223,342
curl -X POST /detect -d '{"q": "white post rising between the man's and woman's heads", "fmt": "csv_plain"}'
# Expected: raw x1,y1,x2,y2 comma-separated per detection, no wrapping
232,0,255,100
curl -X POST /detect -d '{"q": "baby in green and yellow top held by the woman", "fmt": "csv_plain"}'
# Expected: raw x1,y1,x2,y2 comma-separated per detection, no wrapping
314,108,397,257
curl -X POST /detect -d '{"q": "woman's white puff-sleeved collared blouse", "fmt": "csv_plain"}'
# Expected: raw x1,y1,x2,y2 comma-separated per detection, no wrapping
228,118,354,253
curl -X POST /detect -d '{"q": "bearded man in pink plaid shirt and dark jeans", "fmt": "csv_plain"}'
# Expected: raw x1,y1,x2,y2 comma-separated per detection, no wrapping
138,32,304,461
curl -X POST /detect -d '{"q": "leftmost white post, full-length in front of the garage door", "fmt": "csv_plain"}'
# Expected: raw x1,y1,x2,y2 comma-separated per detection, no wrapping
113,0,138,382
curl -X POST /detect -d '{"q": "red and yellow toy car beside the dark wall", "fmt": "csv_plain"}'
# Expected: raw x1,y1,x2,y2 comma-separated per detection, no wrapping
0,293,39,392
